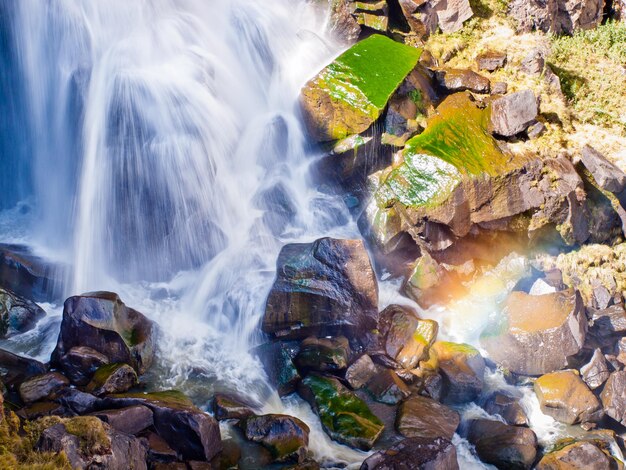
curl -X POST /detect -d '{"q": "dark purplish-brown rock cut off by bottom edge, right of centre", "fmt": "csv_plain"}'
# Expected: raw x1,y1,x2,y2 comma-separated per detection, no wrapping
361,437,459,470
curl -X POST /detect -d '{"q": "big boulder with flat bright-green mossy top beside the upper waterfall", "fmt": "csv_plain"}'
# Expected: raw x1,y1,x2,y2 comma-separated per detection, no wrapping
300,35,420,142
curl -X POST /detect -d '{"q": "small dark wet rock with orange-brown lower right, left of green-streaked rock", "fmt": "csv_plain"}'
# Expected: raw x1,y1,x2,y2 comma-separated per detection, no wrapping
239,415,309,462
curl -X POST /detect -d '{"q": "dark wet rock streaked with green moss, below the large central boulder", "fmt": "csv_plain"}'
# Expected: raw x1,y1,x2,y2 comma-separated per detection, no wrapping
298,374,384,450
